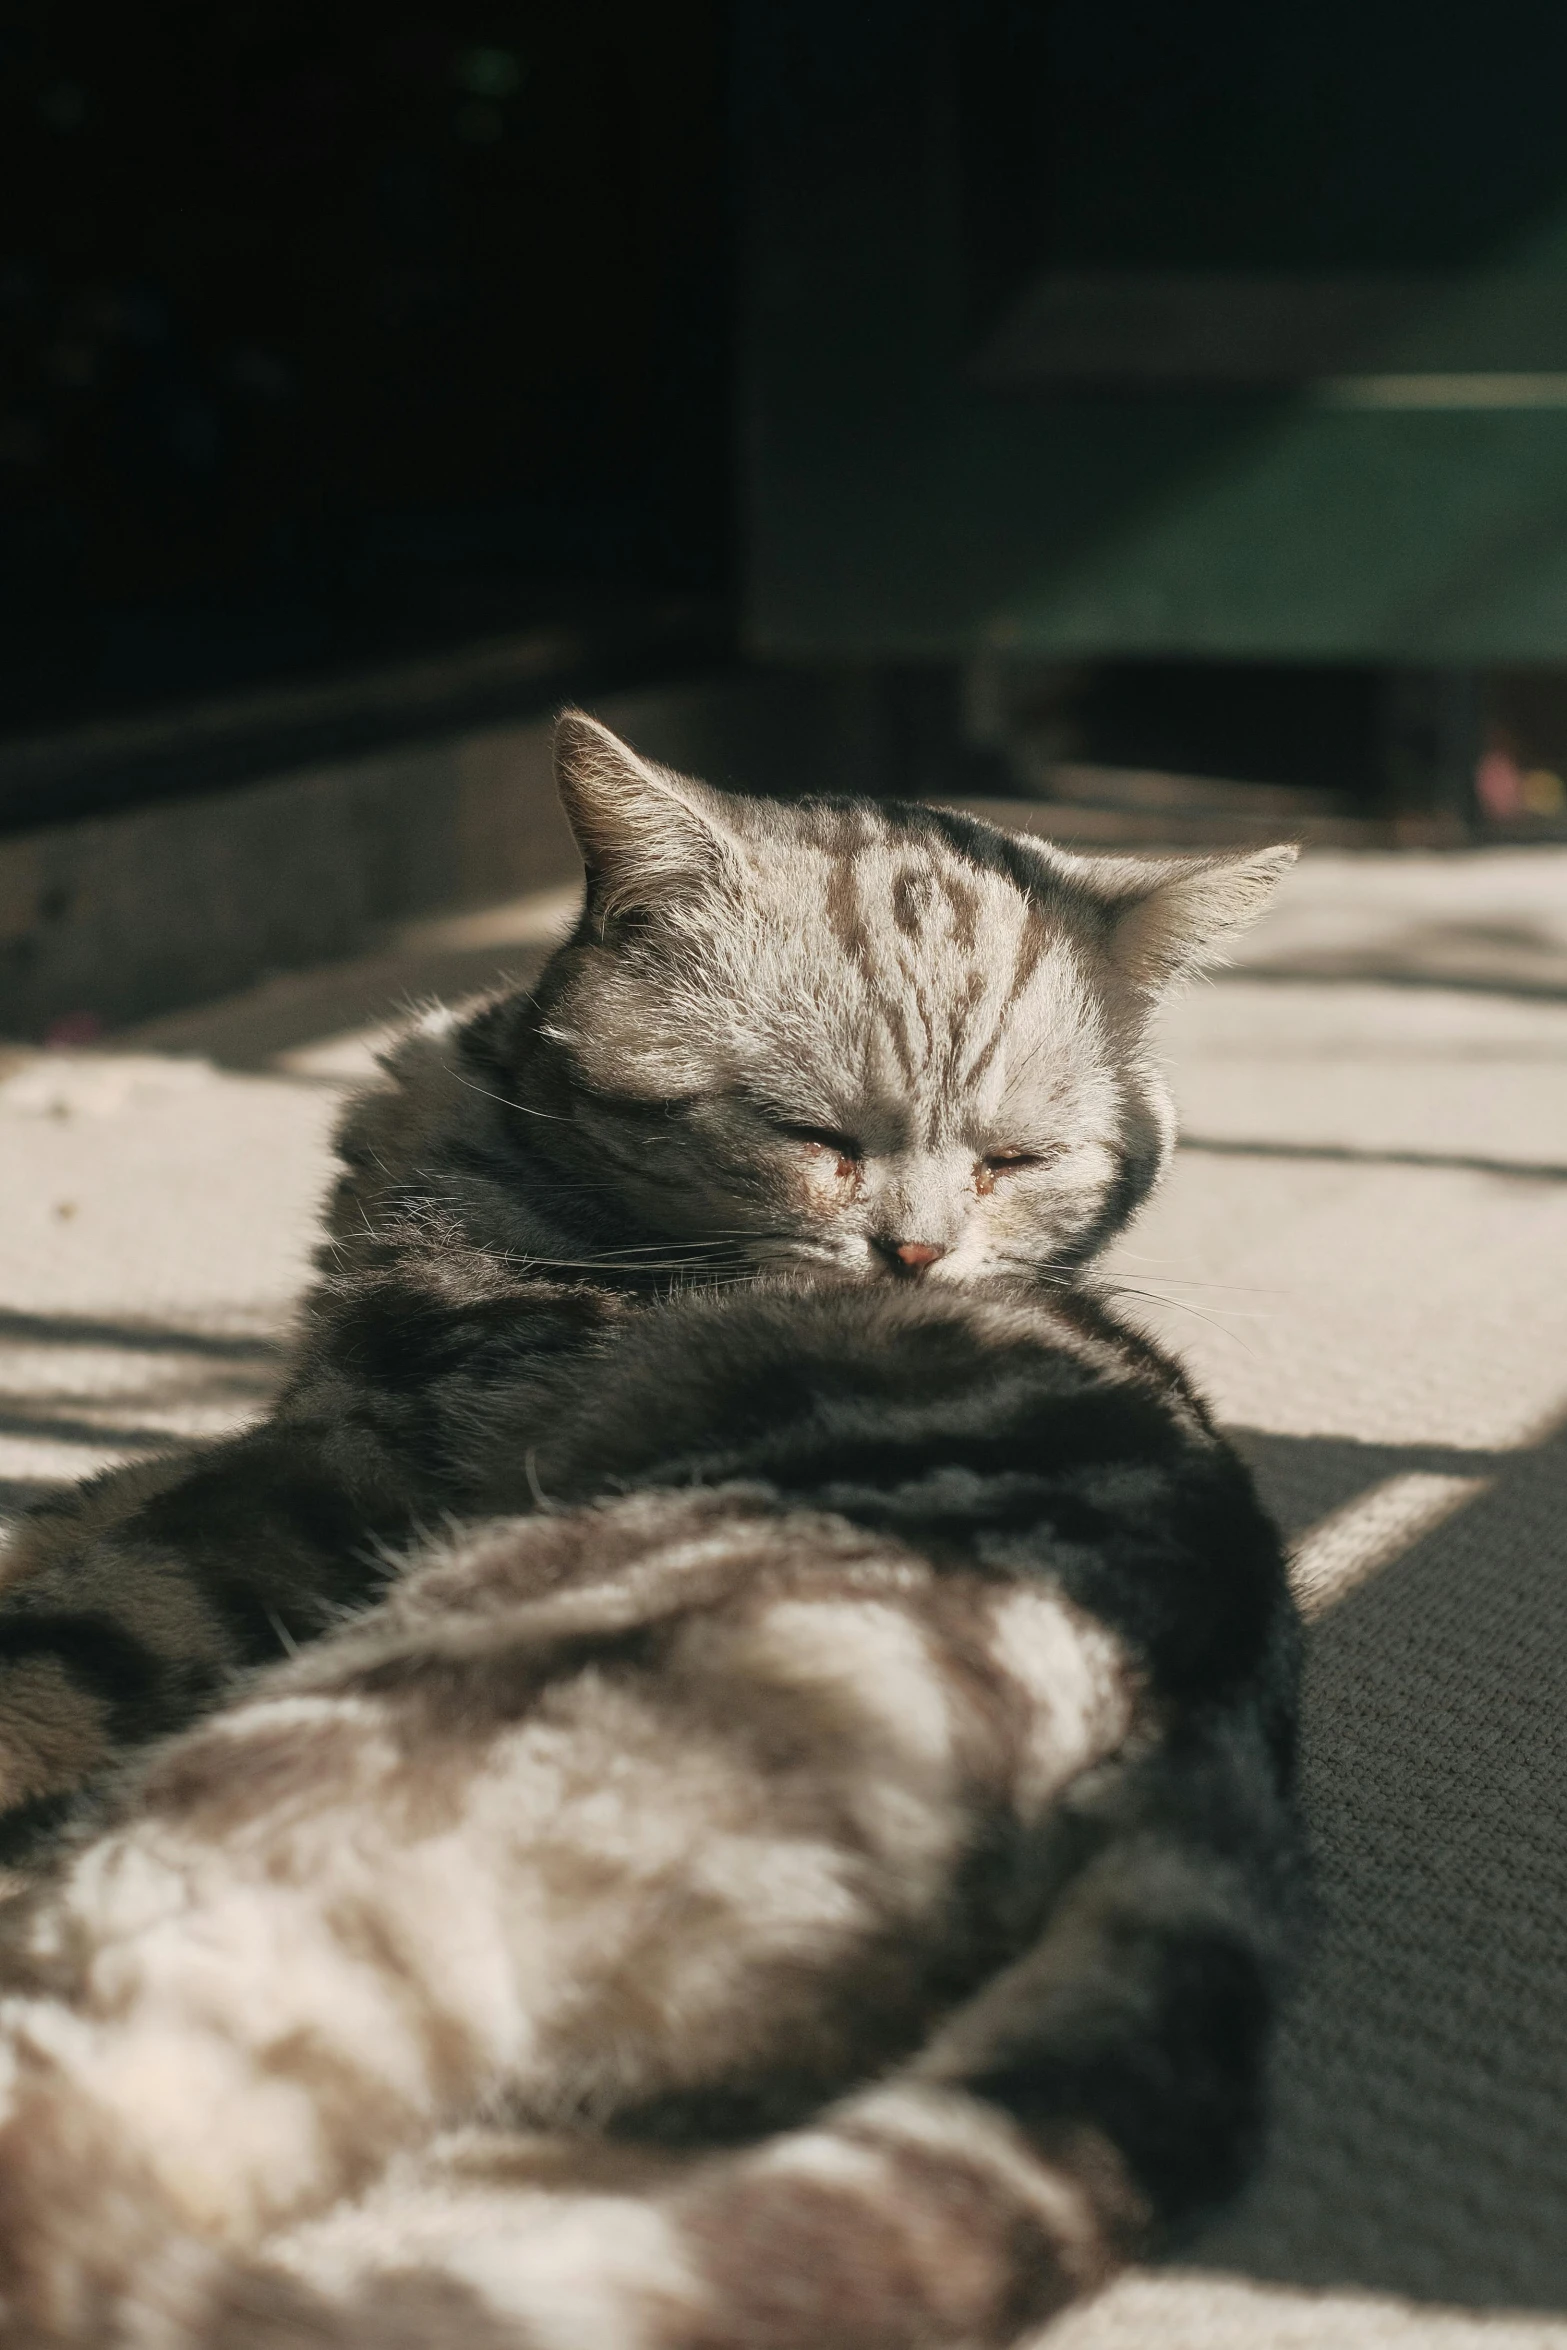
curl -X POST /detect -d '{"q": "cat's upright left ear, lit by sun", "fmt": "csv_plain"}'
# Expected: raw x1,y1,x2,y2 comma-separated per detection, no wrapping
554,710,733,914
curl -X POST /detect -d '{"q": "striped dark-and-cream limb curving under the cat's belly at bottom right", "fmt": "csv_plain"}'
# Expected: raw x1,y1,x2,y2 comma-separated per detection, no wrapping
184,1732,1299,2350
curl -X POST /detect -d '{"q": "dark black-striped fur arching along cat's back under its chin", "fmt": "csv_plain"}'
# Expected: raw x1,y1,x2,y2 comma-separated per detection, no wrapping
489,1283,1297,1739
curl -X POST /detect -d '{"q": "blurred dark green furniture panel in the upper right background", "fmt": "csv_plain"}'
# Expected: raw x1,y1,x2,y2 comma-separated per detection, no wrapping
738,0,1567,830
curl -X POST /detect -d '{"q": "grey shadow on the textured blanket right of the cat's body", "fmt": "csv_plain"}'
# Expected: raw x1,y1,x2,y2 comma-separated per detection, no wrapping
1184,1434,1567,2310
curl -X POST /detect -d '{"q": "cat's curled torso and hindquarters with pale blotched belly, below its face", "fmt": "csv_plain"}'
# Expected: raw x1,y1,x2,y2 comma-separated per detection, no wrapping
0,1269,1302,2350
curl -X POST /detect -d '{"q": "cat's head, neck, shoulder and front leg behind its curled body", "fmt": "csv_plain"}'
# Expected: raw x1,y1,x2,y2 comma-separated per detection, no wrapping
0,712,1294,1864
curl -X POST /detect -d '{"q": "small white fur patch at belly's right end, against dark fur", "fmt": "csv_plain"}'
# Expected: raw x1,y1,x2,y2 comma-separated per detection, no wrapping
991,1591,1132,1819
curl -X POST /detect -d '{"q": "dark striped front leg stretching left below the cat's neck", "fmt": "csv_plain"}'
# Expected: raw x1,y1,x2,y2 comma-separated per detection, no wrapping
0,1253,620,1871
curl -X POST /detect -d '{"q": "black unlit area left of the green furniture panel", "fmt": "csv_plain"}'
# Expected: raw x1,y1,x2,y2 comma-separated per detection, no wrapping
0,0,733,731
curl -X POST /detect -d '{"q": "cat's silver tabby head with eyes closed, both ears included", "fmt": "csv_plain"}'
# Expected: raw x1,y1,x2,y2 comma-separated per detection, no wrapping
526,712,1294,1281
